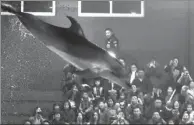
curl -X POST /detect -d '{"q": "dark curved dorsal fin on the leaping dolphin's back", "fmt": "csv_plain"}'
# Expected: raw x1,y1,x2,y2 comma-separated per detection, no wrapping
67,16,85,37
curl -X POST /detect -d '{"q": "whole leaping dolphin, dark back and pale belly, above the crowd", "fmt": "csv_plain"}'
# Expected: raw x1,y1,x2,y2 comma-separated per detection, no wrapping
1,3,128,89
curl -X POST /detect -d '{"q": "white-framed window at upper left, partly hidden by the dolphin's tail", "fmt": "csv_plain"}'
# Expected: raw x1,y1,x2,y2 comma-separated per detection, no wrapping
1,1,56,16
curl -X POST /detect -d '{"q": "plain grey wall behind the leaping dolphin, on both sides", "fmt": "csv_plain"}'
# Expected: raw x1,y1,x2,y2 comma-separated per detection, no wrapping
1,0,194,123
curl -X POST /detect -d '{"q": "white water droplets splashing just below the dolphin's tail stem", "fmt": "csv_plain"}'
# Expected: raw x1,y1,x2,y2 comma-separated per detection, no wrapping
9,18,35,41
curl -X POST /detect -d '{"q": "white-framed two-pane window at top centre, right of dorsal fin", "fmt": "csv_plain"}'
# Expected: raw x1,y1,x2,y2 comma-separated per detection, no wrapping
78,0,144,17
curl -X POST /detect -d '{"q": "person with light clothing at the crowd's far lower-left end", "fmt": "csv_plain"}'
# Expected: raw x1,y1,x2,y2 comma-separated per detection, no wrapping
29,107,46,125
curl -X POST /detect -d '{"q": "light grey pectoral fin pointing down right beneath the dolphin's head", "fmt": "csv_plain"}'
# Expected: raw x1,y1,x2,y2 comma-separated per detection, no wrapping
99,71,129,89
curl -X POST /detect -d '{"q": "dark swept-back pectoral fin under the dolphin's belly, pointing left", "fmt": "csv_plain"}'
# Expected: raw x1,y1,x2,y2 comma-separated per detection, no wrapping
73,69,98,78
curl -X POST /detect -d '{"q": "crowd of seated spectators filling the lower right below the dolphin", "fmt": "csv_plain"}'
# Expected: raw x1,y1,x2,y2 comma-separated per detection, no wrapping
25,58,194,125
